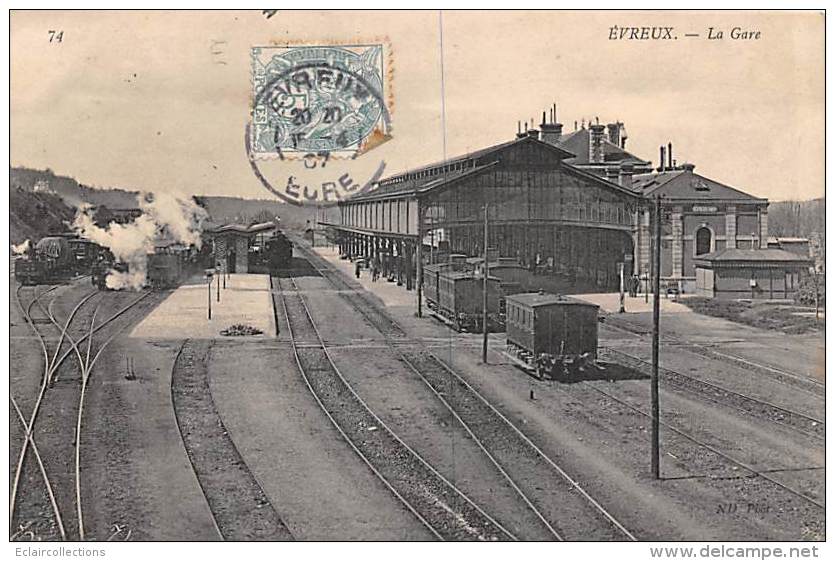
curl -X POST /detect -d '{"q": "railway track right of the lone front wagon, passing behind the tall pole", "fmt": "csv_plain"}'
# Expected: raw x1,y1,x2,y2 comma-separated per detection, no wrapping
601,348,826,440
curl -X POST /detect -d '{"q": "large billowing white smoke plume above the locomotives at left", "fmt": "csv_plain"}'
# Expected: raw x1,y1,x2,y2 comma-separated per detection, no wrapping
73,193,208,290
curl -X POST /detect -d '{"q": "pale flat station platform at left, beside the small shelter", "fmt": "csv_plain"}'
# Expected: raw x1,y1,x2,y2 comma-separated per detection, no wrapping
130,274,276,340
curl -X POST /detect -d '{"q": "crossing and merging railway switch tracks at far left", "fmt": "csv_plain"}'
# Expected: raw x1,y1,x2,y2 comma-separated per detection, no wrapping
9,286,150,540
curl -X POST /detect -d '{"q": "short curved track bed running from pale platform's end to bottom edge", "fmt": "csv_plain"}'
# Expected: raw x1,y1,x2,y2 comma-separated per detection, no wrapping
171,340,293,541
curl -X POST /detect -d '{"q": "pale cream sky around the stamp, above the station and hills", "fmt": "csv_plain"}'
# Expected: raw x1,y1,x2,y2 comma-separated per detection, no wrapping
10,11,825,200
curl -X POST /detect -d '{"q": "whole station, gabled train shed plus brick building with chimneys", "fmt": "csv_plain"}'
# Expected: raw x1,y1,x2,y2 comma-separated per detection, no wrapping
328,110,768,308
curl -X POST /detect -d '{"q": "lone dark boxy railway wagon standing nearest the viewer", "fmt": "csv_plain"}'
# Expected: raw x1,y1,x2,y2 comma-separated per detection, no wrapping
506,292,598,379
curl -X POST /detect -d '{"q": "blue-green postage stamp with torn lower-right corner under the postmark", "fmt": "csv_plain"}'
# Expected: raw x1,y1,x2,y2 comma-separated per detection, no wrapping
251,45,390,158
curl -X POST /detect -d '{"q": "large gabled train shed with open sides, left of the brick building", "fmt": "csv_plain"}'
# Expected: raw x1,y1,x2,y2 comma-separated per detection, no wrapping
329,130,646,316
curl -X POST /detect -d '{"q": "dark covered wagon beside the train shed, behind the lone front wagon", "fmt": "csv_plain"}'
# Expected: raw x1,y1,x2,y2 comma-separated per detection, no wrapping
423,263,501,331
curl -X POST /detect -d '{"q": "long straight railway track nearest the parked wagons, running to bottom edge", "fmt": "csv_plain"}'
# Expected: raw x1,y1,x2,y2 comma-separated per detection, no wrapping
284,246,636,540
